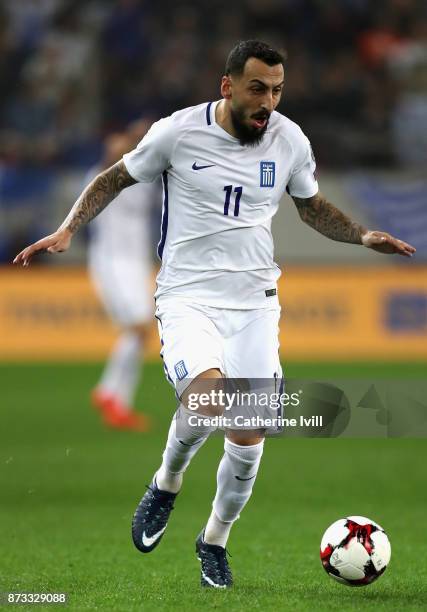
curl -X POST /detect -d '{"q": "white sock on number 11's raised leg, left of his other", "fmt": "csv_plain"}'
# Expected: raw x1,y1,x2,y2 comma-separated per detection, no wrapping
156,404,215,493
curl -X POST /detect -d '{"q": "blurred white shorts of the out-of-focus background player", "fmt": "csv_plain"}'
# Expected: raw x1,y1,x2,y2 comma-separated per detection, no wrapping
89,253,154,327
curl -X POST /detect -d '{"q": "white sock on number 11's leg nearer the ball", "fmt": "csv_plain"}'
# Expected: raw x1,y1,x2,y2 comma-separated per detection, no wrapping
205,438,264,548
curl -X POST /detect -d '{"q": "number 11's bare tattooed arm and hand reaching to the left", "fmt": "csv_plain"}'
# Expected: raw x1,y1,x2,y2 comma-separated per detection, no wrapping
13,160,137,266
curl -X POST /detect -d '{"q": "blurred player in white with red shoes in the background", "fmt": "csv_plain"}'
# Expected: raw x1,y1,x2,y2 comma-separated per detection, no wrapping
85,120,160,431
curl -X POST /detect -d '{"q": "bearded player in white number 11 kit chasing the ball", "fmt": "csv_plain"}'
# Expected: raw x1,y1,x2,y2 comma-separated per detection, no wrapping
15,40,415,588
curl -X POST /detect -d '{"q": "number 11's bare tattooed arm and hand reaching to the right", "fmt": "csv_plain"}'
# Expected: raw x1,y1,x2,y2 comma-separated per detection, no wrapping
292,192,416,257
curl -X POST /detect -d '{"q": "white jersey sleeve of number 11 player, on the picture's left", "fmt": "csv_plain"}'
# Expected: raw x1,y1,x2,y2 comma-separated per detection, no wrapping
123,117,176,183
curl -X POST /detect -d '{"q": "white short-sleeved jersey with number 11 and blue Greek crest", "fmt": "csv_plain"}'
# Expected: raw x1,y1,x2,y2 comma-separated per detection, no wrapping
123,101,318,309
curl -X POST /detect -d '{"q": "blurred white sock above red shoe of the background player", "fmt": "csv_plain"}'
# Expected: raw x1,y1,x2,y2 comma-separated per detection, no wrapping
98,332,142,406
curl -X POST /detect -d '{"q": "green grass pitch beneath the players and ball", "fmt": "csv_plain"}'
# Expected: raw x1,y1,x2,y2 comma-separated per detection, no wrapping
0,363,427,612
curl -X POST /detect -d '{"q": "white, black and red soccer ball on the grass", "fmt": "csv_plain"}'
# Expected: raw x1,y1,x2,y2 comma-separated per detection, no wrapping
320,516,391,586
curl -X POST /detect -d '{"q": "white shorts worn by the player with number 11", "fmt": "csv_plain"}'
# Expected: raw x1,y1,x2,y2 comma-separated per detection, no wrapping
155,298,282,397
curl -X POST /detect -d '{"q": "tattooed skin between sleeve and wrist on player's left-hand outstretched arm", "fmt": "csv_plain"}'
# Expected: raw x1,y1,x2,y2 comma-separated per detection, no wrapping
60,161,137,234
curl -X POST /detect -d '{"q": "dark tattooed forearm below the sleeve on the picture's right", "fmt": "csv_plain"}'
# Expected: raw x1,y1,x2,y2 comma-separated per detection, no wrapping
293,193,366,244
